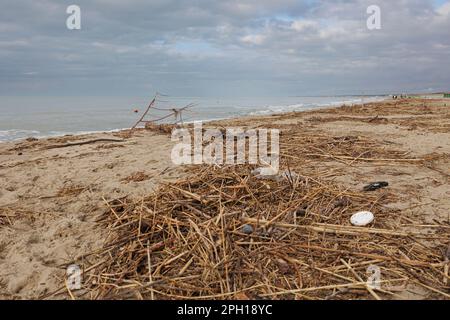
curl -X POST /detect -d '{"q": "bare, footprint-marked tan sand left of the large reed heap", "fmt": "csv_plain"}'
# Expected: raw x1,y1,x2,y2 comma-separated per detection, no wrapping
0,132,181,298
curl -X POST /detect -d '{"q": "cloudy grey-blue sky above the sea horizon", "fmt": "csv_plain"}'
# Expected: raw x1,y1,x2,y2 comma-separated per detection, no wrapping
0,0,450,97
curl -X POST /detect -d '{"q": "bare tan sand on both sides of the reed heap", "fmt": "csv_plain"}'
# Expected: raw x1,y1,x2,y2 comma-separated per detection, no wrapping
0,99,450,299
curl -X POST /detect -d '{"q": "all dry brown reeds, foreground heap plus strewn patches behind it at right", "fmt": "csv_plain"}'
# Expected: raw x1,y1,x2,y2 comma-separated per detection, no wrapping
53,101,450,299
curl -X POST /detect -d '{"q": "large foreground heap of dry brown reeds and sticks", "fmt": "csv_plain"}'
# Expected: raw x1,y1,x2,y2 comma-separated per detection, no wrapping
76,163,447,299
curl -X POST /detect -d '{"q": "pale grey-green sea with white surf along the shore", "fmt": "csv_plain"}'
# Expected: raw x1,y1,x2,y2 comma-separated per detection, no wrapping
0,96,387,142
